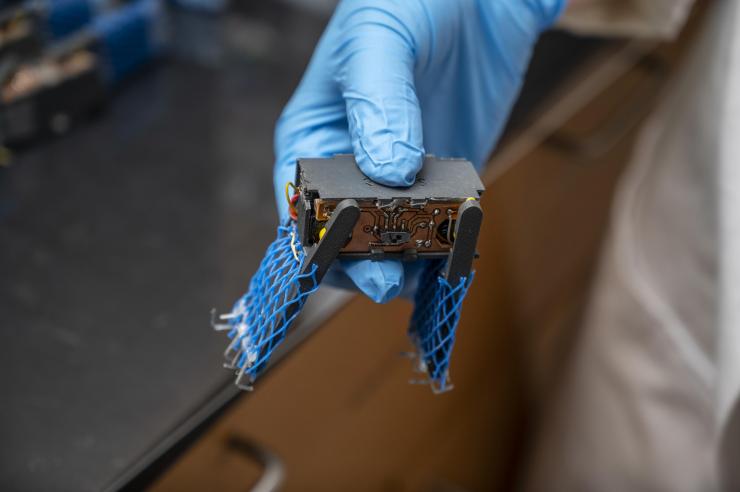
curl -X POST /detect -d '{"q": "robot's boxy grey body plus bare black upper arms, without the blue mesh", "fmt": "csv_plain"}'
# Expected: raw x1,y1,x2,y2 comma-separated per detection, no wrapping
290,155,484,296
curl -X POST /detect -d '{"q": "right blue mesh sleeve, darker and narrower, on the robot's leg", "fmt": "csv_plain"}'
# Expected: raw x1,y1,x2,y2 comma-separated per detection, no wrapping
409,260,475,392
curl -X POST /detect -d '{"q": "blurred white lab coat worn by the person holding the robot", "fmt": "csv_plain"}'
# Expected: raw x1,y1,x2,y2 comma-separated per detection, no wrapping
527,0,740,492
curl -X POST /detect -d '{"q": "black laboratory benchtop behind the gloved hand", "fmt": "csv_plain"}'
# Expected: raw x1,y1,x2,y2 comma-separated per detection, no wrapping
0,3,599,491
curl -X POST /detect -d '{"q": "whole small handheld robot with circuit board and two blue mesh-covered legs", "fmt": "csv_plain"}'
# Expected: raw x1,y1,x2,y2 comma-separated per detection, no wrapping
212,155,483,392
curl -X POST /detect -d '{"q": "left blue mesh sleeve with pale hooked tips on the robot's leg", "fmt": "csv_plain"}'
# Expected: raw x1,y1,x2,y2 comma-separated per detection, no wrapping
215,225,319,387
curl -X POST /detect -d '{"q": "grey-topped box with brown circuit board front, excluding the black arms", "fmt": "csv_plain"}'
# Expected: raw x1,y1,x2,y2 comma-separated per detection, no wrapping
292,155,483,261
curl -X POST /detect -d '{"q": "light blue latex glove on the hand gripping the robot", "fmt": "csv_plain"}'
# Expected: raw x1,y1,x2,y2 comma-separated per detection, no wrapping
274,0,565,302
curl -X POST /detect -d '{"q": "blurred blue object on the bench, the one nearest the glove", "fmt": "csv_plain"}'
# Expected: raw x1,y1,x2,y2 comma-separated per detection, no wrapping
92,0,165,84
